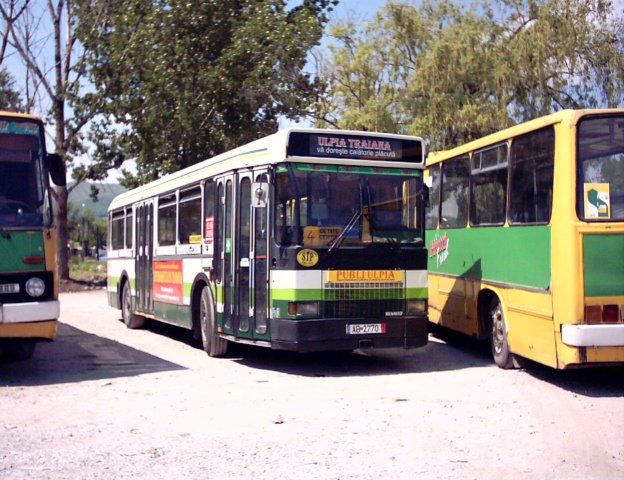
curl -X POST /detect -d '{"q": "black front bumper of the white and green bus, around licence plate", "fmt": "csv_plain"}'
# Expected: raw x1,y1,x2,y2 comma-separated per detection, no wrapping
270,317,428,352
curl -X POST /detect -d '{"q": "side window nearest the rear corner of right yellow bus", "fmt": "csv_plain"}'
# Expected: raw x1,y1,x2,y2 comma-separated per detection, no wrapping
509,126,555,224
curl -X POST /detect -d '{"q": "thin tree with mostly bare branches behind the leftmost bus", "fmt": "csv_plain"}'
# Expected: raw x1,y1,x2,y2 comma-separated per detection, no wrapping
0,0,106,279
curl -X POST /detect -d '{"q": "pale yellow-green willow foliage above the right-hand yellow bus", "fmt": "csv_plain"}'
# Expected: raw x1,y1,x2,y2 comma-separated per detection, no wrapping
316,0,624,149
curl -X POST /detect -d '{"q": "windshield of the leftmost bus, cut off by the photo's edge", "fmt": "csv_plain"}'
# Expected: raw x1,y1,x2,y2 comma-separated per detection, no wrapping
0,120,50,228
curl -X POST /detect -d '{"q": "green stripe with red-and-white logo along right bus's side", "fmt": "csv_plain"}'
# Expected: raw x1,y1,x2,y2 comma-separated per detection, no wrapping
427,226,550,290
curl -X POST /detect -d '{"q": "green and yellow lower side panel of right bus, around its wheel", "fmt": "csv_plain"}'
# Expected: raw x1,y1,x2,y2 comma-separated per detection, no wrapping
428,226,556,344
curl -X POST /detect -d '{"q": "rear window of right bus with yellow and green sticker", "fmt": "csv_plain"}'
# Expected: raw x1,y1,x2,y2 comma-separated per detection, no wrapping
578,115,624,221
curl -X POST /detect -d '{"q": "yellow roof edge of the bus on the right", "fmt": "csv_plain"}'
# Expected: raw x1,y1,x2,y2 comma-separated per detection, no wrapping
427,108,624,165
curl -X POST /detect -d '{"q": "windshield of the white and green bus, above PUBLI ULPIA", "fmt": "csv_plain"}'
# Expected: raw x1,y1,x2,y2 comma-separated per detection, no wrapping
275,164,424,250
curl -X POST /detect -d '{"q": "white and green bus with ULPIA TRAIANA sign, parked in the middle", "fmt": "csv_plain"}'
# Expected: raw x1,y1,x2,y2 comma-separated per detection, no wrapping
108,129,427,356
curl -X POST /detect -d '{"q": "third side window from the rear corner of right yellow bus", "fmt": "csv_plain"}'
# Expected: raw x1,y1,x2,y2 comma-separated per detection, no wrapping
440,155,470,228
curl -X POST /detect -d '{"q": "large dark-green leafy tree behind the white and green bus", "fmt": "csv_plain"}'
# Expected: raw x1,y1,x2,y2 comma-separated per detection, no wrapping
77,0,337,187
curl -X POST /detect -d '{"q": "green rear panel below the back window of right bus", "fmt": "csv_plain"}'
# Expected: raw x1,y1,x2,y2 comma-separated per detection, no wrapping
583,233,624,297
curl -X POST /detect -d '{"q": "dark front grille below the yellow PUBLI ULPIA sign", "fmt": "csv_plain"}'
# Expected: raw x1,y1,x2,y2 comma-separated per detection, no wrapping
323,282,405,318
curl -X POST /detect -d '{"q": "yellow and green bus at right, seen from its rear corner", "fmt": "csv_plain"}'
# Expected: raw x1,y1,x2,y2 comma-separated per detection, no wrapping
426,109,624,369
